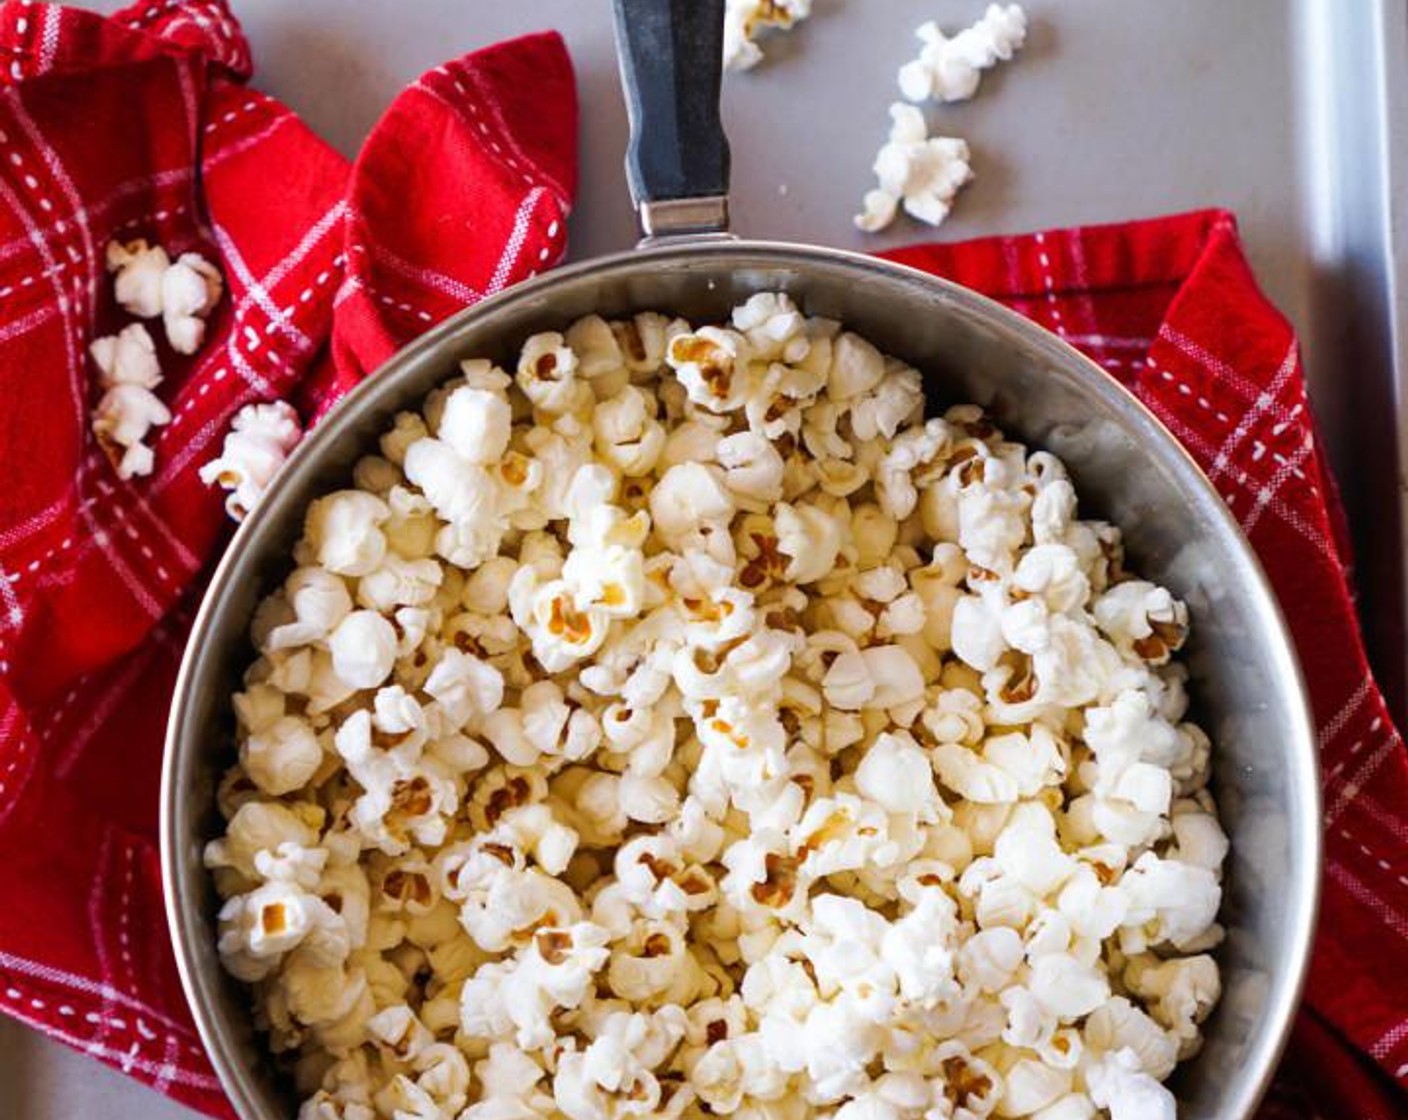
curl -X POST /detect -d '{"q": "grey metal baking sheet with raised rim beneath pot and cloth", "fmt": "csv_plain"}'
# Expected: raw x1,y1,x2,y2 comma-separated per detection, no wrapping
11,0,1408,1120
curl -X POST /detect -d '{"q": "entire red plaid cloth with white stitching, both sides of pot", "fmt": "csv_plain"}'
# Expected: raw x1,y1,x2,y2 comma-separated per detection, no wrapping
0,0,1408,1120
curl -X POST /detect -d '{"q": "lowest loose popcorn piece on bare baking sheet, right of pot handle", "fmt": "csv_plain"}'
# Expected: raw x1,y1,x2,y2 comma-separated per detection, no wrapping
856,101,973,234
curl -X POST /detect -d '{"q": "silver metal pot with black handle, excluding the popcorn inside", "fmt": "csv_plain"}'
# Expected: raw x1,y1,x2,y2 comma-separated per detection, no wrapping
161,0,1321,1120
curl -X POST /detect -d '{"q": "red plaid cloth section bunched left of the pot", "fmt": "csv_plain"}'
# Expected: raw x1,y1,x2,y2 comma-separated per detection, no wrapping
0,0,577,1114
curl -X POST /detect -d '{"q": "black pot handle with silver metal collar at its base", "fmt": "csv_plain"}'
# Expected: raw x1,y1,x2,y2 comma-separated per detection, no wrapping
614,0,728,238
